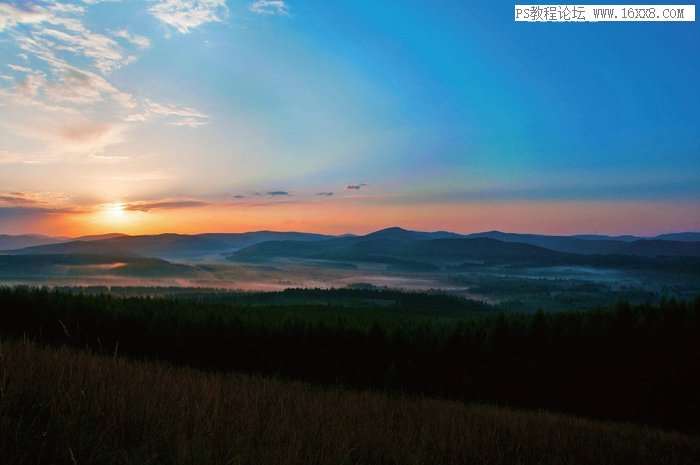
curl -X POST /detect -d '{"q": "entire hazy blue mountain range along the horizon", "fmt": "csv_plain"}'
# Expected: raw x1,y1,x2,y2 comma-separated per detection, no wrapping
0,227,700,271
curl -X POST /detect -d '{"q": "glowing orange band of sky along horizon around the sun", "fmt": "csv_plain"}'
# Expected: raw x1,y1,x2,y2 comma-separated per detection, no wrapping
5,200,700,237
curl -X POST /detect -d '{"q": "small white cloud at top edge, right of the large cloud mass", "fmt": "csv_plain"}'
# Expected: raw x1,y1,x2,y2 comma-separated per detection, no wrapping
149,0,228,34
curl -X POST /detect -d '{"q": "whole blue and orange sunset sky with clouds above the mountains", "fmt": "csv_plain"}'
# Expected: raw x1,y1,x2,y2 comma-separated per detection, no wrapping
0,0,700,236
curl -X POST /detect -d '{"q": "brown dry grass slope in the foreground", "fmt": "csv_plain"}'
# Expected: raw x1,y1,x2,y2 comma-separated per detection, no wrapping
0,341,700,465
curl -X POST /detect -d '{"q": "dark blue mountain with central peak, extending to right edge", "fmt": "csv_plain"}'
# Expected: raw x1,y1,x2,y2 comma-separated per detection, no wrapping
228,228,700,271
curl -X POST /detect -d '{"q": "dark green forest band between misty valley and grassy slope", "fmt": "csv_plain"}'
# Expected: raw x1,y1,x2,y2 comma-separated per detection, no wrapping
0,287,700,433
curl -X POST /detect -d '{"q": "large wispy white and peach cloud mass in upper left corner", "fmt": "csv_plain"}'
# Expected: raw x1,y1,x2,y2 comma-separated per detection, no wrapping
0,0,208,158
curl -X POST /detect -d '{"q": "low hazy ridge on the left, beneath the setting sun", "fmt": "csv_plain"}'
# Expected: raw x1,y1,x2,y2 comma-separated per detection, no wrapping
5,231,329,259
